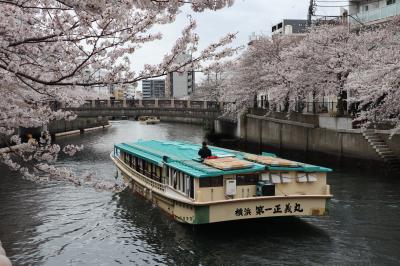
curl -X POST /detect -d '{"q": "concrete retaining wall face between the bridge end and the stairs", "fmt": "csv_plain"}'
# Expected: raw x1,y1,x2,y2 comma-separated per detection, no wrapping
244,115,384,160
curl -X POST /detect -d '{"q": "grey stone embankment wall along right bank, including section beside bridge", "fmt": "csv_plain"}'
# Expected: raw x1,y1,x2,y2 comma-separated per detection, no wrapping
216,114,400,165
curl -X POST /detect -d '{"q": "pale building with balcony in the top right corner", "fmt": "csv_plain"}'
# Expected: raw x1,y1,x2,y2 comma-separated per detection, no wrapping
349,0,400,26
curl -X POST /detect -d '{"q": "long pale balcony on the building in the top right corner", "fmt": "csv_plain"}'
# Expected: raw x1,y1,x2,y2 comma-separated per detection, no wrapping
350,2,400,25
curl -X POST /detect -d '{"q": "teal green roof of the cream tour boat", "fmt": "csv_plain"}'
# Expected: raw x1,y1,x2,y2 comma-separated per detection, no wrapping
115,140,331,178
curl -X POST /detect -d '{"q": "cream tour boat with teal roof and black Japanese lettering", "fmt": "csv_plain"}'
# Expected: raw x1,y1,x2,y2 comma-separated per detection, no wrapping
110,140,332,224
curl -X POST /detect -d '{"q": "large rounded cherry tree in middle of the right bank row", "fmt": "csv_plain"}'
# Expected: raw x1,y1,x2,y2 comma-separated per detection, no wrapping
273,25,360,115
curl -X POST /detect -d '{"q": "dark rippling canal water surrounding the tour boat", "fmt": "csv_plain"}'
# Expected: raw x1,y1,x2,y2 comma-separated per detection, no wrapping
0,121,400,265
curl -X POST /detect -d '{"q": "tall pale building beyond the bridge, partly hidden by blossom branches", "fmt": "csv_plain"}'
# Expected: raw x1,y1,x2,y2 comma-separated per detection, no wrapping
166,54,195,99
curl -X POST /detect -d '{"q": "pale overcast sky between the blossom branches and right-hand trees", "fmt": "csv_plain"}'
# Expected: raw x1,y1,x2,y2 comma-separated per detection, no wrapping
132,0,339,83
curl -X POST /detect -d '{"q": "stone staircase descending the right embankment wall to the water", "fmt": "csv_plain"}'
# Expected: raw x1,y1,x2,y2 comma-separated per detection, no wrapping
363,129,400,173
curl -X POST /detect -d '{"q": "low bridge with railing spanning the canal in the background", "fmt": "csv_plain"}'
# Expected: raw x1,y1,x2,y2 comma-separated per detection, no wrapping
61,99,223,123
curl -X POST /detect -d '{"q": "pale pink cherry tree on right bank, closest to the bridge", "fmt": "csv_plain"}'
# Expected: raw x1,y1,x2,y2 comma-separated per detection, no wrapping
219,34,298,112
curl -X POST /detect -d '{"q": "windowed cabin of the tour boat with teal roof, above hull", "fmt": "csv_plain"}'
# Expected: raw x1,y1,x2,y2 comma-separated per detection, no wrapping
114,140,331,203
